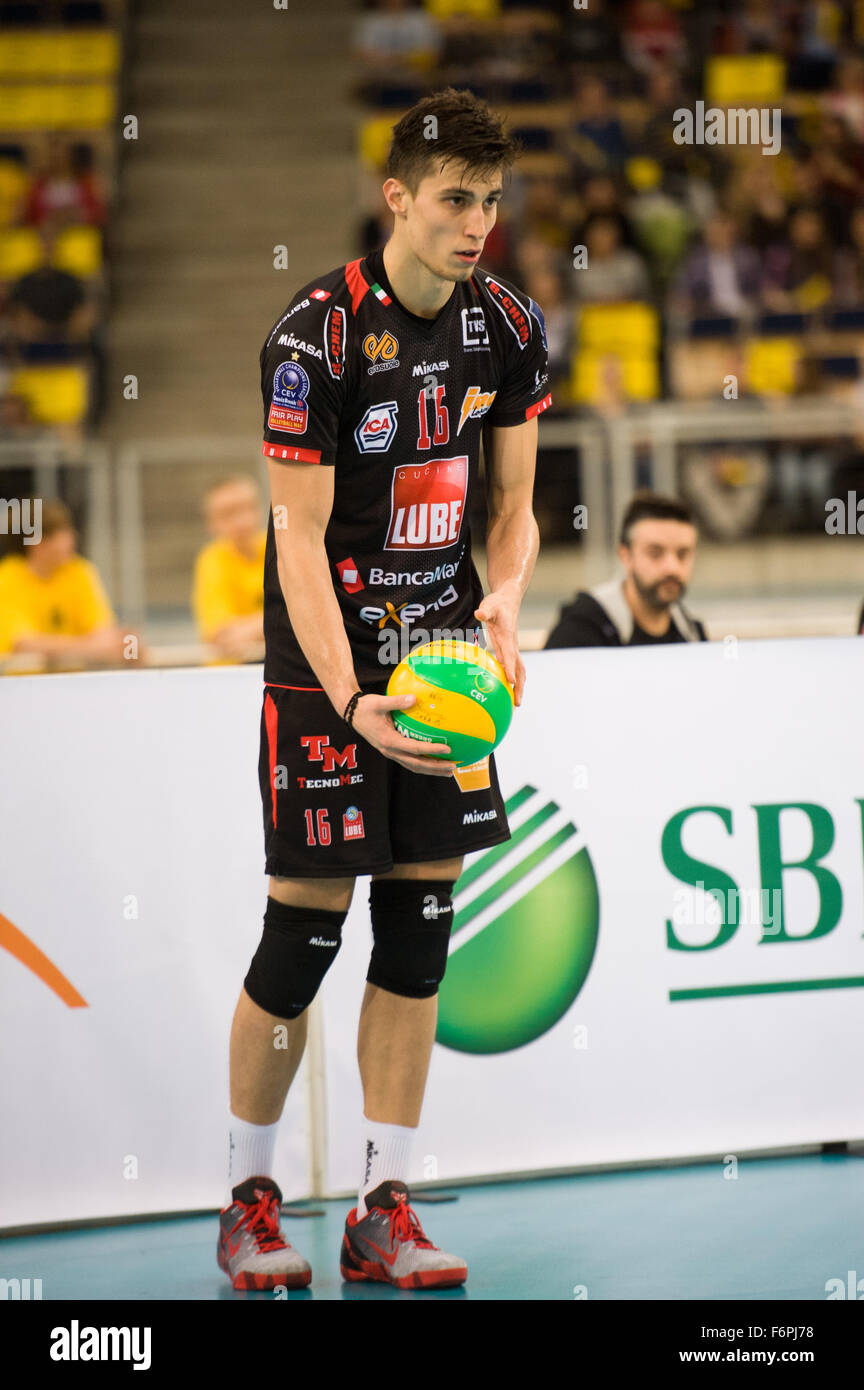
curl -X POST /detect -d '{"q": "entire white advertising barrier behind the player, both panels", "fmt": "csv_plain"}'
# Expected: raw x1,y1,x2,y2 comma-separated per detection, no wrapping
0,638,864,1226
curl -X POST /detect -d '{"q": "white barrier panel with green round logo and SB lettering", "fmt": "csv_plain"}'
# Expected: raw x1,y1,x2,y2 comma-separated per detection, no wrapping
324,638,864,1193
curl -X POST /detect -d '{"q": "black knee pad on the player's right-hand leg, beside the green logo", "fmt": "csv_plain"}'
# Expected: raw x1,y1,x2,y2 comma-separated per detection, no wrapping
367,878,456,999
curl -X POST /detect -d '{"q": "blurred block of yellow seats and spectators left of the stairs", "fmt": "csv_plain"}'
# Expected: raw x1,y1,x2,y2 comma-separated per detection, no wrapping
0,0,121,442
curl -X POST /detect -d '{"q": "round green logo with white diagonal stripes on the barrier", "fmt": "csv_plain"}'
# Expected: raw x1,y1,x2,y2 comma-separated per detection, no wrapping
436,785,600,1054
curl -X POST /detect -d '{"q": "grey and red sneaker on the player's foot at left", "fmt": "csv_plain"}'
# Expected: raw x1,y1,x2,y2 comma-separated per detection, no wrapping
217,1177,313,1289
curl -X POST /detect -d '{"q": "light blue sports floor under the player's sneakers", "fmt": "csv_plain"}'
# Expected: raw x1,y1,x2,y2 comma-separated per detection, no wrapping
0,1154,864,1301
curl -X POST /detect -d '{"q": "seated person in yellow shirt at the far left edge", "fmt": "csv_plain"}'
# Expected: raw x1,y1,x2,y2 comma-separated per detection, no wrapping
0,502,129,667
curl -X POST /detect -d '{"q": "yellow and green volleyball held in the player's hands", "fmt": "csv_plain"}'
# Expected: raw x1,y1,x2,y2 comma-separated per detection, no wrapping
388,638,514,767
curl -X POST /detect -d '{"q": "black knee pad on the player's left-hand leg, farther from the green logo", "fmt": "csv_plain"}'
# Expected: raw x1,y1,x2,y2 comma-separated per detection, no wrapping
243,898,347,1019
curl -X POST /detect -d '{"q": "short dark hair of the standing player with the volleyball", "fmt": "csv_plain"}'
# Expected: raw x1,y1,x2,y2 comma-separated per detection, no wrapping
383,88,520,195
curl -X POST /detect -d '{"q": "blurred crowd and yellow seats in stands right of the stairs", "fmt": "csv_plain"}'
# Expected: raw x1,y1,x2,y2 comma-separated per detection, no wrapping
354,0,864,539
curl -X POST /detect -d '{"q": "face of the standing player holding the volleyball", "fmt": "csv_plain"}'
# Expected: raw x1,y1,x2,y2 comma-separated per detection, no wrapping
403,164,503,281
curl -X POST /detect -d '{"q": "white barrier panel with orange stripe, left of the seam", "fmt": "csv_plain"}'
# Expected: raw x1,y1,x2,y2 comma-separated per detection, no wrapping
0,666,308,1228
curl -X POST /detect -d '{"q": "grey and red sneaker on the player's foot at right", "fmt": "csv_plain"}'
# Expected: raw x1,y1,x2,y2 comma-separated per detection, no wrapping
339,1182,468,1289
